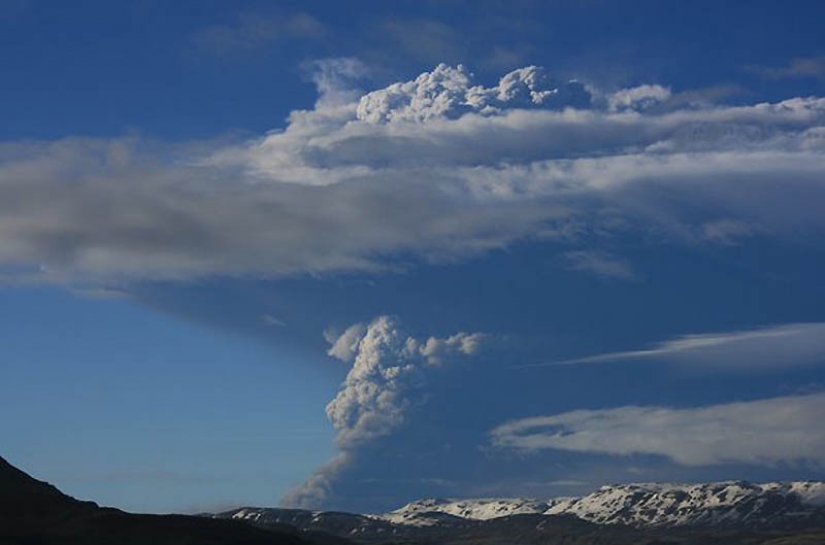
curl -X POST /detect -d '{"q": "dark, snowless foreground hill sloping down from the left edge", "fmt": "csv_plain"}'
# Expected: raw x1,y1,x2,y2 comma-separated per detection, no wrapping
0,458,347,545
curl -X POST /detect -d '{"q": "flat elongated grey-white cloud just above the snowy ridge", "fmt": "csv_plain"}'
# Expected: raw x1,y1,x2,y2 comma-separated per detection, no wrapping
490,393,825,466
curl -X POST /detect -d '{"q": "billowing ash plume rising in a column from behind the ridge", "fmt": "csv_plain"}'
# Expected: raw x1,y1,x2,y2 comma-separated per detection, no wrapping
282,316,484,508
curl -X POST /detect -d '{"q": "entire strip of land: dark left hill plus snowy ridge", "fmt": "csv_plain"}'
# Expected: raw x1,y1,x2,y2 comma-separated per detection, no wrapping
0,458,825,545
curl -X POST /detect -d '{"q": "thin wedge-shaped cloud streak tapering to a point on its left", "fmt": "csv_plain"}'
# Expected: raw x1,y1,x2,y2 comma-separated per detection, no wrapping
540,323,825,369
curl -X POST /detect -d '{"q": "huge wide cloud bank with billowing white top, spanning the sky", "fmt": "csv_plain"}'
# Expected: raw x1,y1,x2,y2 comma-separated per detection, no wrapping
0,65,825,285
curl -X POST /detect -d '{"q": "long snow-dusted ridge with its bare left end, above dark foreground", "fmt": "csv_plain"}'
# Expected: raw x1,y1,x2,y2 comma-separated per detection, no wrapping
215,481,825,542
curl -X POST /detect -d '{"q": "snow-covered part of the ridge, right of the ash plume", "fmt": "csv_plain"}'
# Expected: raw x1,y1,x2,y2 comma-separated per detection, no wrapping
374,481,825,528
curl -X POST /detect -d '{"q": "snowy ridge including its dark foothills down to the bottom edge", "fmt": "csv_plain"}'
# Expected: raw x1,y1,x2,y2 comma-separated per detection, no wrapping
214,481,825,545
